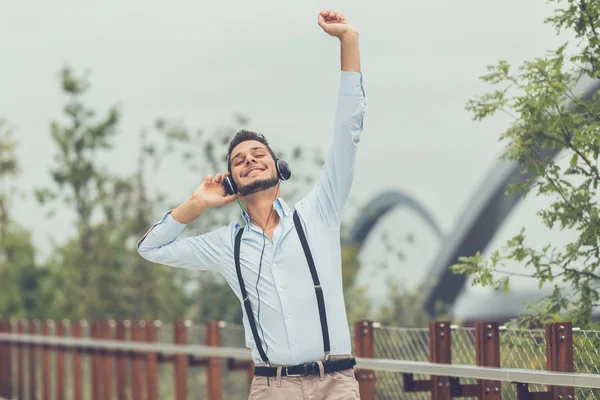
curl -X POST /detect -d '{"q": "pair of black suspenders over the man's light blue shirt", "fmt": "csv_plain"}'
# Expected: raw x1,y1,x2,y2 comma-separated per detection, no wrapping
234,211,330,364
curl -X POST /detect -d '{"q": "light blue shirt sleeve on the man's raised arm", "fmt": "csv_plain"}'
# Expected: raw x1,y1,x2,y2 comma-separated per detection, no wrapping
304,71,366,227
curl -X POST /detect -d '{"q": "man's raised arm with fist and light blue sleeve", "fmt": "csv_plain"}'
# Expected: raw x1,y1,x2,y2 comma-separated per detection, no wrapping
304,11,366,228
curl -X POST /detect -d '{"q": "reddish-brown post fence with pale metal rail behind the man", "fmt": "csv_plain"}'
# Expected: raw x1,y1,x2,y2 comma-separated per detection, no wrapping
0,321,600,400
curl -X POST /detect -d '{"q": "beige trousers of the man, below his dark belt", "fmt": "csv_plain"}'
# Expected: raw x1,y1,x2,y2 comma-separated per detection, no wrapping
248,355,360,400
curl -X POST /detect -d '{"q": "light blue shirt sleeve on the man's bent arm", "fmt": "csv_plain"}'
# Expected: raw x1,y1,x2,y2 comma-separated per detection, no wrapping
137,212,227,270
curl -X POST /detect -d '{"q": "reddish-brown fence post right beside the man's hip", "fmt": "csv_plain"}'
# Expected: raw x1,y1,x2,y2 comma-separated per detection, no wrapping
354,320,375,400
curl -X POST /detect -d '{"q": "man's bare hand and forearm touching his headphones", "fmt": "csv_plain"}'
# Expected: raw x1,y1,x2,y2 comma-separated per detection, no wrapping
171,172,237,224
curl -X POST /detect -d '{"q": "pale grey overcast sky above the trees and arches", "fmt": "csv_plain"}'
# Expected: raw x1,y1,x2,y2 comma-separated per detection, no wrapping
0,0,576,318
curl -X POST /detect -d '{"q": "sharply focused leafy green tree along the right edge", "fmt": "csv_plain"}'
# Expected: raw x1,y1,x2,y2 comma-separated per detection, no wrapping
452,0,600,327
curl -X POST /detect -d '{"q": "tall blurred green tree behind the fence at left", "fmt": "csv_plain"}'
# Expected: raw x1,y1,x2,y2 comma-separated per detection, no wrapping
36,68,185,319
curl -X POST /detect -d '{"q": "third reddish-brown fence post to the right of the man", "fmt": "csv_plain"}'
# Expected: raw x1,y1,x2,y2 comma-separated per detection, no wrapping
475,322,502,400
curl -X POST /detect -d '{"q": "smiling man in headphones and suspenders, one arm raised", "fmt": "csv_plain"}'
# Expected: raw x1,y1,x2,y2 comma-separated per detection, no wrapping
138,11,365,400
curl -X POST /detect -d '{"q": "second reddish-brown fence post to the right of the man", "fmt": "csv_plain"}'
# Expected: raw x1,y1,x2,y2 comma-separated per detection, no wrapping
429,321,452,400
